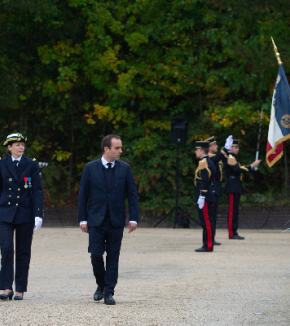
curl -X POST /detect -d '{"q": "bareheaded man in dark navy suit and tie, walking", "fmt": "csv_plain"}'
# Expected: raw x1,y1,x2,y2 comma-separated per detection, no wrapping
78,135,139,305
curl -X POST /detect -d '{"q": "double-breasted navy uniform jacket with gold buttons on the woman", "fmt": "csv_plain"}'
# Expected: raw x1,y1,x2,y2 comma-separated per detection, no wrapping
0,155,43,224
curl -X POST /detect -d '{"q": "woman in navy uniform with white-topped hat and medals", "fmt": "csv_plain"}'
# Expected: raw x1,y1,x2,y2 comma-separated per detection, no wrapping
0,133,43,300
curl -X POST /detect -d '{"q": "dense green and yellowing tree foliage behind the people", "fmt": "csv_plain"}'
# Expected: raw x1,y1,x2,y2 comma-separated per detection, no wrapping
0,0,290,213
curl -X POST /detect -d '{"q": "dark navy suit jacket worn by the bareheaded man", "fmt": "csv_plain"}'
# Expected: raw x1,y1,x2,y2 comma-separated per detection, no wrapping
78,159,139,227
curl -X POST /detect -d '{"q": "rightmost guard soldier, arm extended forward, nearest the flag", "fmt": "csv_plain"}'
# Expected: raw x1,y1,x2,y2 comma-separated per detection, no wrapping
224,140,261,240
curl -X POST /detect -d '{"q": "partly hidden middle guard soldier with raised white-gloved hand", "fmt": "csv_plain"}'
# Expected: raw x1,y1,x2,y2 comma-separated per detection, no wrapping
206,136,233,246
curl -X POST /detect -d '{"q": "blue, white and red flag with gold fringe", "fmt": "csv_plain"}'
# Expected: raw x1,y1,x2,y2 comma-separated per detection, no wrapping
266,63,290,167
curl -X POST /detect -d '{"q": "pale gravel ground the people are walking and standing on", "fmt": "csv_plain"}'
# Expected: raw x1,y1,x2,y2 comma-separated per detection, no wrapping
0,228,290,326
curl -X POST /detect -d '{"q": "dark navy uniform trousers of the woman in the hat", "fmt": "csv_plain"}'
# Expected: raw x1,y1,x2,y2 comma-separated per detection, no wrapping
0,221,34,292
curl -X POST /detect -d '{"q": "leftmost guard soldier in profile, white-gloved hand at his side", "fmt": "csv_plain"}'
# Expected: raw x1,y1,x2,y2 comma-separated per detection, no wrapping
195,141,215,252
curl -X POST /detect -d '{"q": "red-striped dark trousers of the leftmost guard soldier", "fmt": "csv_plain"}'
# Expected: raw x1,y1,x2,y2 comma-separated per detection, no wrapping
197,201,214,251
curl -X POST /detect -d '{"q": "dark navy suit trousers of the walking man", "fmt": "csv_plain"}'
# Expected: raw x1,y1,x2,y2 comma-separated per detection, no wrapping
89,217,124,295
